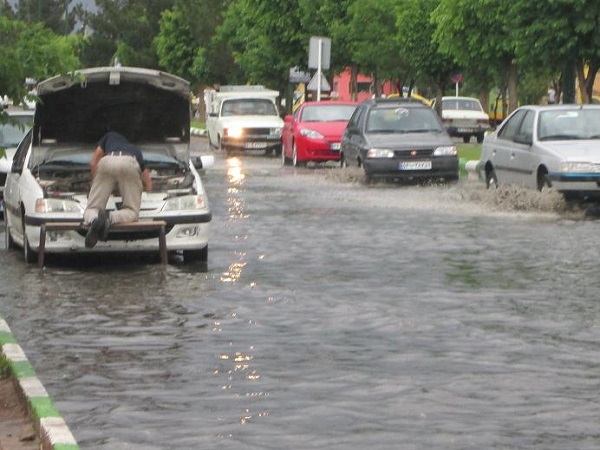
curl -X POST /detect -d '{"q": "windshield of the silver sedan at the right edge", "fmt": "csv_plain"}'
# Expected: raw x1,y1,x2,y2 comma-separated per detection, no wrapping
538,109,600,141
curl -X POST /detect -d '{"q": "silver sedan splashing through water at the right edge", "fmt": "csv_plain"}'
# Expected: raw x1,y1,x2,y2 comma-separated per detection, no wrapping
480,105,600,199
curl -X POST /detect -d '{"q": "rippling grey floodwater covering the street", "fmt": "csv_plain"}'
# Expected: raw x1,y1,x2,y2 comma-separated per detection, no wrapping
0,140,600,450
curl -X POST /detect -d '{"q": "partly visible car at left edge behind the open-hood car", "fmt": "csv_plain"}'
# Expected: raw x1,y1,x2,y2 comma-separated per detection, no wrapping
0,109,33,216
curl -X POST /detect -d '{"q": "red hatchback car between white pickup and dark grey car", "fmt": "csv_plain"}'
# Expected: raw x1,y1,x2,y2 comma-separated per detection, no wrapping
281,101,357,166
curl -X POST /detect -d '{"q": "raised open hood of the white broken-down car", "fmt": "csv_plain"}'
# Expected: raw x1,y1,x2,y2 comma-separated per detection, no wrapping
34,67,190,145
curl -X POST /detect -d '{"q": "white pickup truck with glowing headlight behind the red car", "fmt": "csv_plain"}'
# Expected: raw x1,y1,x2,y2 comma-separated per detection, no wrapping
204,86,283,154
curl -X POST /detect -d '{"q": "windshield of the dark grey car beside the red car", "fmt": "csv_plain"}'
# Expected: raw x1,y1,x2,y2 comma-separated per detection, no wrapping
367,107,442,133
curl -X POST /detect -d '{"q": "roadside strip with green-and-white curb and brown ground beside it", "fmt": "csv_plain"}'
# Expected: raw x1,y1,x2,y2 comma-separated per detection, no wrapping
0,317,79,450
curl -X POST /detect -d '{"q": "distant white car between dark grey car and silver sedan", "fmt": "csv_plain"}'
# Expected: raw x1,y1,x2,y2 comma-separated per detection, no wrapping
442,97,490,143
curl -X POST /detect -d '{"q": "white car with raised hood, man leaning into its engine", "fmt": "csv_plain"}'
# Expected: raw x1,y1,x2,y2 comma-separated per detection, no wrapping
4,67,212,263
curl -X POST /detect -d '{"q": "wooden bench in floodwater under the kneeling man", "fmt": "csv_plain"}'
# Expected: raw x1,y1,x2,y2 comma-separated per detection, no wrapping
38,220,167,267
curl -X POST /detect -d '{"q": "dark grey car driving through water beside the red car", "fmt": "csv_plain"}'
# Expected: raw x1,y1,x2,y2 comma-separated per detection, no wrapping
340,98,458,182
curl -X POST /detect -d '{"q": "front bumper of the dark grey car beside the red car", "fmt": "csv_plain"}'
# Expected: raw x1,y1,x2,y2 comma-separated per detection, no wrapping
363,157,459,180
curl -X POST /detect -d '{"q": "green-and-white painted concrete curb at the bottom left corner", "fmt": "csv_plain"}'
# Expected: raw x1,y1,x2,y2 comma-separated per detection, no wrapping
0,317,79,450
